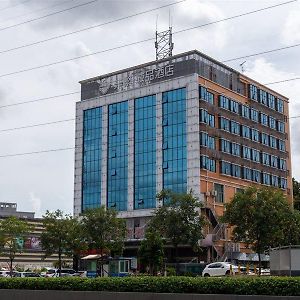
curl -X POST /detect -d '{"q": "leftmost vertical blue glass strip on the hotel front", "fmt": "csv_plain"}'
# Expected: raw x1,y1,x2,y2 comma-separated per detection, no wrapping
82,107,102,211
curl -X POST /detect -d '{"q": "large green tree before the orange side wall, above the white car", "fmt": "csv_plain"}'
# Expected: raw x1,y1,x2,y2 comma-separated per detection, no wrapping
223,187,292,273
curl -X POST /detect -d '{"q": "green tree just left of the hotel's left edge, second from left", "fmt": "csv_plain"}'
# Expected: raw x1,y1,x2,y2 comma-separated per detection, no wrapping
41,210,86,276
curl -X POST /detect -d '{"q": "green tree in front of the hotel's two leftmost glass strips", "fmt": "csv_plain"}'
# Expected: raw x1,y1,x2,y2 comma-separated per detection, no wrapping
82,206,126,276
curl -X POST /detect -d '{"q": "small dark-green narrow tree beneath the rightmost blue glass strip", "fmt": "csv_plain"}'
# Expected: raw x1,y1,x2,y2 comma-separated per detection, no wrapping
138,228,164,275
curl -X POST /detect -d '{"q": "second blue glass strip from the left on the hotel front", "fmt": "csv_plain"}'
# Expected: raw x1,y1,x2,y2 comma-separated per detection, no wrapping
107,101,128,210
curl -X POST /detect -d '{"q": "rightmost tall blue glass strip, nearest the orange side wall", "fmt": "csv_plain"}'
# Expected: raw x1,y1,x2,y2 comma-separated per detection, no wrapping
162,88,187,193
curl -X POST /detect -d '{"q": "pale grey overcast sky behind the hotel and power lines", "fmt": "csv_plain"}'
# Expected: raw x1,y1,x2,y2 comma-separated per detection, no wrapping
0,0,300,216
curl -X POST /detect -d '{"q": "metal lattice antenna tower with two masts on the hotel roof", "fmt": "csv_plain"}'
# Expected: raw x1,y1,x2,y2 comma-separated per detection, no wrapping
155,12,174,60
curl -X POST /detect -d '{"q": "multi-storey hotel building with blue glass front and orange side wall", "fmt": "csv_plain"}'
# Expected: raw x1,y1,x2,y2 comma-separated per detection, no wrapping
74,50,292,260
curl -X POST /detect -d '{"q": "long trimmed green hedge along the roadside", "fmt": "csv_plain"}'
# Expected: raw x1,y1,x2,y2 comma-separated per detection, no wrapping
0,276,300,296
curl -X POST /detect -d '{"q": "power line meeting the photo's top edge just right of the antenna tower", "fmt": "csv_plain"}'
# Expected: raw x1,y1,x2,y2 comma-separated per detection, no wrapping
0,0,187,54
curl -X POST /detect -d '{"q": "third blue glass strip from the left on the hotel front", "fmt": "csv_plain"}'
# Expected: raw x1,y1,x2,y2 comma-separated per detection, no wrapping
134,96,156,209
